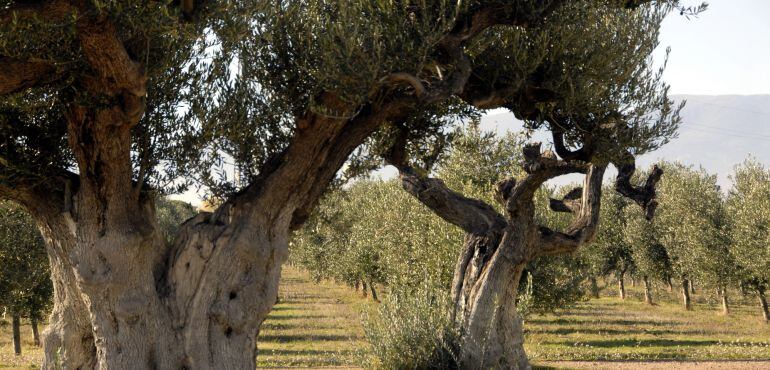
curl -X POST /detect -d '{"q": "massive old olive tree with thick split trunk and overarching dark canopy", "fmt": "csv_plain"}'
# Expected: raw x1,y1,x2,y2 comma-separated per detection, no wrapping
0,0,696,369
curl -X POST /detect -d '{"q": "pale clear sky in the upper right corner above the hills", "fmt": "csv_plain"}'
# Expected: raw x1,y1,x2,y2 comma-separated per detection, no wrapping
661,0,770,95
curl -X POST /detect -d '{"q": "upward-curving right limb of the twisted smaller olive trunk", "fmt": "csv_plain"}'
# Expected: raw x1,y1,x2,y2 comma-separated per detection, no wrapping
535,164,606,257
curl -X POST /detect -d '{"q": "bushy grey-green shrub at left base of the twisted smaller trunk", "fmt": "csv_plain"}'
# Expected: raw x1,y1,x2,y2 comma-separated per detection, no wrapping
364,287,459,369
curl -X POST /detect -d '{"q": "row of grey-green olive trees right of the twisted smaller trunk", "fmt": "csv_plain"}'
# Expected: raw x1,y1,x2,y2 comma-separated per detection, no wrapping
581,159,770,320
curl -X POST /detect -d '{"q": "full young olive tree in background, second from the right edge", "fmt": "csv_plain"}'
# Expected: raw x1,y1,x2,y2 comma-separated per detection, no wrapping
656,163,735,313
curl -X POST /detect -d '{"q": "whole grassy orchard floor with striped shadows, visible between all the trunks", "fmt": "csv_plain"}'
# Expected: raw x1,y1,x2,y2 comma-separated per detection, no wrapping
0,267,770,369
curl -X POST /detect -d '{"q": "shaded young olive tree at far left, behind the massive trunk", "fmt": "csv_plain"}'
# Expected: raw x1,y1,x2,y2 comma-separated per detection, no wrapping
0,201,53,354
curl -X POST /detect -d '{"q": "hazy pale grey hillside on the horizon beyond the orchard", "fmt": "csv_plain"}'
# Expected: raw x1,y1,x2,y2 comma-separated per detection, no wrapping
482,95,770,188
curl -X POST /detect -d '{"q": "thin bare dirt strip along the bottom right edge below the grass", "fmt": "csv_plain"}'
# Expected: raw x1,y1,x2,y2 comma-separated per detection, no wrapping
537,361,770,370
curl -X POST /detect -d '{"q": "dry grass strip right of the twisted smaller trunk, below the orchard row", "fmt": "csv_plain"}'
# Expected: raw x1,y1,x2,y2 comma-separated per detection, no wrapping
525,278,770,366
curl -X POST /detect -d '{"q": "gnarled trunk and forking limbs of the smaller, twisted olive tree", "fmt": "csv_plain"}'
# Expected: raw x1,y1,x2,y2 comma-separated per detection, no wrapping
390,144,605,369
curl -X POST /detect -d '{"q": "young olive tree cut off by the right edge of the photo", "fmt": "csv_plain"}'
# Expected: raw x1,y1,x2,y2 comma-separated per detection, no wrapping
727,159,770,322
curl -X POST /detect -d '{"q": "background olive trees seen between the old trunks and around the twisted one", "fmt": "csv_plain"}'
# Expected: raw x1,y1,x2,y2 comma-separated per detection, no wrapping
290,124,583,310
